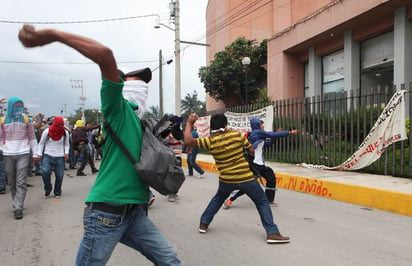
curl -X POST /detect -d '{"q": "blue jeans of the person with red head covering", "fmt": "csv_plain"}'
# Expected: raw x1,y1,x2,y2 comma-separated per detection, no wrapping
41,154,64,196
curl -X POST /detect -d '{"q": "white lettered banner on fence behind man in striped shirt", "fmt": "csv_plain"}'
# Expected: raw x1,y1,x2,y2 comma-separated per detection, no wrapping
195,106,273,138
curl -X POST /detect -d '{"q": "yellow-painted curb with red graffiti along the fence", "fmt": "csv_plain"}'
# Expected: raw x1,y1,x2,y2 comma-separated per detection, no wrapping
182,158,412,217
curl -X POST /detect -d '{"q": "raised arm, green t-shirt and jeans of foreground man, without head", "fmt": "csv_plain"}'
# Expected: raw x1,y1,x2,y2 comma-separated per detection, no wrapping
19,25,180,265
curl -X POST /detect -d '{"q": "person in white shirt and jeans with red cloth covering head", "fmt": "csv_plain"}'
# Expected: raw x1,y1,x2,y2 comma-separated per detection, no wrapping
37,116,70,198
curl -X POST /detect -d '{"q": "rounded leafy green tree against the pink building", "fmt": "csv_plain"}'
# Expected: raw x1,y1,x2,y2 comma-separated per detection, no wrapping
199,37,267,107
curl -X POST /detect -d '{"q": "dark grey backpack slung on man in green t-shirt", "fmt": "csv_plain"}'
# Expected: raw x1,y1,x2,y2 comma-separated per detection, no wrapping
102,117,185,195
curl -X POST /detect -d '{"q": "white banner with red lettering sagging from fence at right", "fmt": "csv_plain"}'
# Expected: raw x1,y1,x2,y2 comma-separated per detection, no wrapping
300,90,407,170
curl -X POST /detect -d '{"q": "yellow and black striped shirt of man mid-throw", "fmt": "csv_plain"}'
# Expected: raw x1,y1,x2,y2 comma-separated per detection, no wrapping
197,130,253,183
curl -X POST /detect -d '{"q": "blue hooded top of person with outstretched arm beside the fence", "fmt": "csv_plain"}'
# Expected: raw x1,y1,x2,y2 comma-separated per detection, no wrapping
249,118,289,149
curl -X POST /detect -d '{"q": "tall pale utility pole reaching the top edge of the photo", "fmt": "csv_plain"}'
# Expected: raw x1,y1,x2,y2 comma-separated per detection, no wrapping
169,0,181,116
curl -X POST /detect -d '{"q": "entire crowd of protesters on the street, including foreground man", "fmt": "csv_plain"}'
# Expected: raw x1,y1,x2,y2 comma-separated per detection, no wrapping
0,25,297,265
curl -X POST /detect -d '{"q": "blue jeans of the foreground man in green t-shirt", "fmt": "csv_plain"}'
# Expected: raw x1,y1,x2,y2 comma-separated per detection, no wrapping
76,205,181,266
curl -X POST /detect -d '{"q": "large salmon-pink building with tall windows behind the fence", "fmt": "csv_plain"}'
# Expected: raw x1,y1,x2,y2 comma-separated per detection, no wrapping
206,0,412,111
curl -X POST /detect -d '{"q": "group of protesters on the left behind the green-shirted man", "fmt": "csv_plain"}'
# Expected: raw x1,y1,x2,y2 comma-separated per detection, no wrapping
0,97,102,209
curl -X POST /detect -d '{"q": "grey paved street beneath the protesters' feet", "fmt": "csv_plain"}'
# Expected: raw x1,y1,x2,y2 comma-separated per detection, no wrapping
0,163,412,266
